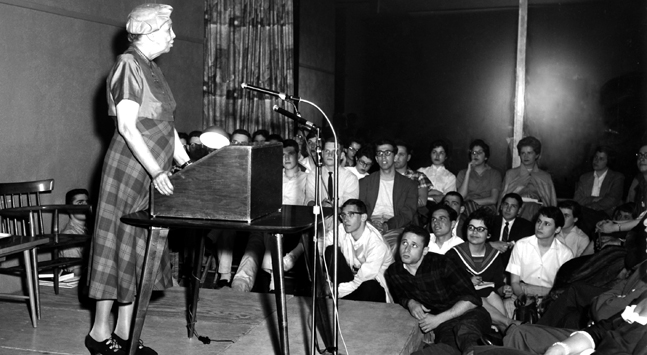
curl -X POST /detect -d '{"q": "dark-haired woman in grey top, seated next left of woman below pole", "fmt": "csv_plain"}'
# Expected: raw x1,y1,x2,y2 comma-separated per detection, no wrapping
456,139,501,215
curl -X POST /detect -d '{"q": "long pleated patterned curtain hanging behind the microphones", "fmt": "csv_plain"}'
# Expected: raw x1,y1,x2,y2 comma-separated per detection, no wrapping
203,0,294,137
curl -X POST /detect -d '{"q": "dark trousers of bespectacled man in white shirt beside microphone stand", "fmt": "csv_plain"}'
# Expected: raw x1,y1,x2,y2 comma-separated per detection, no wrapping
324,245,386,302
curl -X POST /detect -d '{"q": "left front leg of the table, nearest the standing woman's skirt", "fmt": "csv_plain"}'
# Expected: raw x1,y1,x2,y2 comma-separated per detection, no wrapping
128,227,168,355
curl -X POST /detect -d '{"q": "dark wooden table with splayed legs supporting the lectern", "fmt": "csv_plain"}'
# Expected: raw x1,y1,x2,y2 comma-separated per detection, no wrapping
121,205,324,355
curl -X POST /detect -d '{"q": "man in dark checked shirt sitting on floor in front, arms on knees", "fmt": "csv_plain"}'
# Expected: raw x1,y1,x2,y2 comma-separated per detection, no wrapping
385,225,491,355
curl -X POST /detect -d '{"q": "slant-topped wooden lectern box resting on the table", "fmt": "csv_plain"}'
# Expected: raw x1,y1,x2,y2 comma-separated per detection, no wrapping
150,143,283,223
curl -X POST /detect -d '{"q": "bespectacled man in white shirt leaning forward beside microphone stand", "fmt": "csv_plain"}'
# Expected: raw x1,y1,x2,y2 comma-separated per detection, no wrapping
325,199,393,302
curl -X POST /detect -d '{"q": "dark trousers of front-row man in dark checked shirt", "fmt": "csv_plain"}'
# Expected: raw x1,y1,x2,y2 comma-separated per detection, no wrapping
413,307,492,355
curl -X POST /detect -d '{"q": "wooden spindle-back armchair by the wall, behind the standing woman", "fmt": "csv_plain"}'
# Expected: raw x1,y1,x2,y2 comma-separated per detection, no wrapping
0,179,91,294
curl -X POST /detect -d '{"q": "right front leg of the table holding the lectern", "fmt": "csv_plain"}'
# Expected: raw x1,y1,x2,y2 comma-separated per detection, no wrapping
270,233,290,355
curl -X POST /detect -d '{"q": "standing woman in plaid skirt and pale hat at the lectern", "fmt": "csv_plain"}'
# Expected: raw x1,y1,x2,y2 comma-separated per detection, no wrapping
85,4,191,354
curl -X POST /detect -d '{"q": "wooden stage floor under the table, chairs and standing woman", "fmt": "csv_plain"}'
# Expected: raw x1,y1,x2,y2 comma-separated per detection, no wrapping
0,287,421,355
